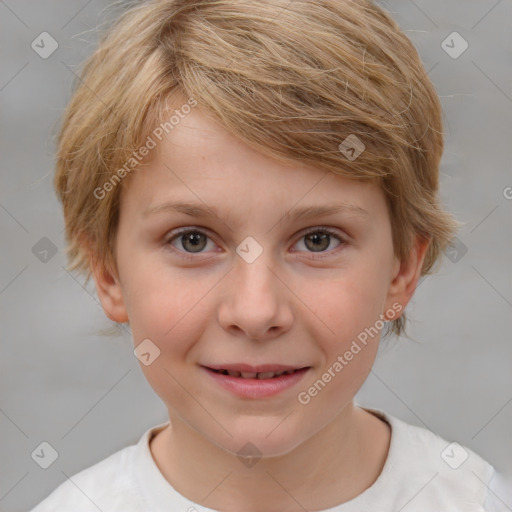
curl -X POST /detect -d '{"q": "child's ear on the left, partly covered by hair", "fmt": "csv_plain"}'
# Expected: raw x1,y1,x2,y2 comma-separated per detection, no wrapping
91,253,128,323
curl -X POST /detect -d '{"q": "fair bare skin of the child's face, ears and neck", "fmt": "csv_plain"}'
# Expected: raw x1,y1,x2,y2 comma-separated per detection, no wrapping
93,102,427,512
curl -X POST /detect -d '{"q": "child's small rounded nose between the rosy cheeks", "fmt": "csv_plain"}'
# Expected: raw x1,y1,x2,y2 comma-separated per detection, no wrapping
218,251,293,341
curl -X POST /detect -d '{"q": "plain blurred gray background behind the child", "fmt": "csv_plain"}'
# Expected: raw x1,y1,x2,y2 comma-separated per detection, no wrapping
0,0,512,511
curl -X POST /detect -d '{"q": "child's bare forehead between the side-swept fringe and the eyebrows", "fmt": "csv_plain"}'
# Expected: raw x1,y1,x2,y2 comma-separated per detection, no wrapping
122,107,383,225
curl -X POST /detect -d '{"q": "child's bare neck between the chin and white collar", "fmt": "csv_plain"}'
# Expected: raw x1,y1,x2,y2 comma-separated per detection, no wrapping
151,402,390,512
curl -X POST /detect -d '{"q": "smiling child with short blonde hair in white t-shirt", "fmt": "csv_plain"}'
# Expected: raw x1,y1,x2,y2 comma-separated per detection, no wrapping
30,0,506,512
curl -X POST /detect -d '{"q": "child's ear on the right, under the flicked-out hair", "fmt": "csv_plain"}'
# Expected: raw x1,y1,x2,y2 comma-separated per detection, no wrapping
385,236,430,311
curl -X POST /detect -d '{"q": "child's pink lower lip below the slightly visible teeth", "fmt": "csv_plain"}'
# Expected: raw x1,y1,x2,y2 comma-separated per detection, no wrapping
201,366,309,398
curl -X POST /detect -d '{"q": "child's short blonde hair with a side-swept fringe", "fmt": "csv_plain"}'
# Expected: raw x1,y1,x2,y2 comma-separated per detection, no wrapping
54,0,457,335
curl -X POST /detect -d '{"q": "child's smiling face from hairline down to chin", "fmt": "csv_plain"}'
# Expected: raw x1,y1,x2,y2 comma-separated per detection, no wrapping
95,108,422,455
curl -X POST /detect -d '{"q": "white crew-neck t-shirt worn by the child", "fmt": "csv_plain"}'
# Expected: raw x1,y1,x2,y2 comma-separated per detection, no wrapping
31,409,511,512
